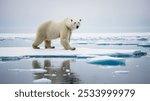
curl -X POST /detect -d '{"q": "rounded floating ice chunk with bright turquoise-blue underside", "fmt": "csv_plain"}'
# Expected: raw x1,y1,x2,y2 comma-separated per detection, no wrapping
87,56,125,66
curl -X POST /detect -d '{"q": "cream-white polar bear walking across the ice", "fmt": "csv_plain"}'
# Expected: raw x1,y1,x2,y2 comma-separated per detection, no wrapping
32,18,81,50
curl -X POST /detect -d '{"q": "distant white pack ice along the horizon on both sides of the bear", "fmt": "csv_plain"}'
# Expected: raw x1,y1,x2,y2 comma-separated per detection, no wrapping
0,33,150,46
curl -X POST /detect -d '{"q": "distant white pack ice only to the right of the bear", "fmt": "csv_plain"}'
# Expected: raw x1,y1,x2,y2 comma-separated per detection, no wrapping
72,33,150,45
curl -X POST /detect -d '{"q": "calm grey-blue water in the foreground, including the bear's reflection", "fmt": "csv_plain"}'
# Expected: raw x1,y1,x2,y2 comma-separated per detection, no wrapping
0,54,150,84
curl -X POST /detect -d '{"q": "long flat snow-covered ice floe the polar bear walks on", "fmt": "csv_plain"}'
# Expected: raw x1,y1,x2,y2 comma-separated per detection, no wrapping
0,47,146,61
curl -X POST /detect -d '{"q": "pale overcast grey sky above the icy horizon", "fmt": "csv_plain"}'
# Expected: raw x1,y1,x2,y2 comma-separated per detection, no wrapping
0,0,150,33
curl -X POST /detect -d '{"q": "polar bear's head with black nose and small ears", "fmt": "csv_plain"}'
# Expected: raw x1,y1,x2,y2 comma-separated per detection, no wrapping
65,18,81,30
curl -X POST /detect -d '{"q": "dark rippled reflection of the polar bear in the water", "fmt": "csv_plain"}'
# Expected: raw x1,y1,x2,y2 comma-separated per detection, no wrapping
32,59,80,84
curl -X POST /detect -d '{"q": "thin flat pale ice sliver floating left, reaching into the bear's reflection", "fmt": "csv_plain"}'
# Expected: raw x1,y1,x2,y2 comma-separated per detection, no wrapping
9,69,47,73
